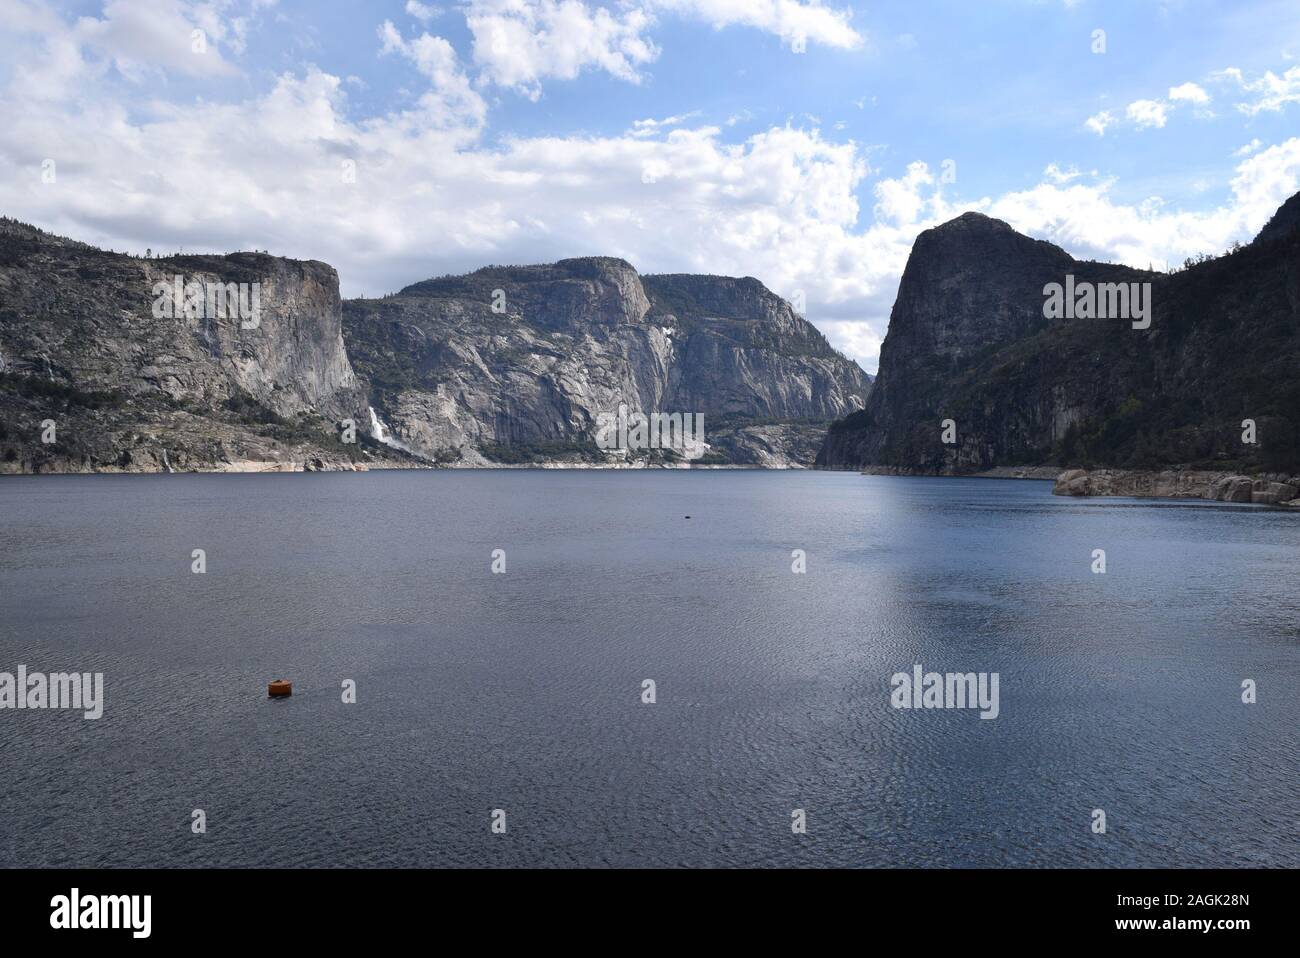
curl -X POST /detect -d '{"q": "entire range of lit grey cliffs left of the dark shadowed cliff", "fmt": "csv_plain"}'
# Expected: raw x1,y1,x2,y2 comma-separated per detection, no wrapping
0,220,870,473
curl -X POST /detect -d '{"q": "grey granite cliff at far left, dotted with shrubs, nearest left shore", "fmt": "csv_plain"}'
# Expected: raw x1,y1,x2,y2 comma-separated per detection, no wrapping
0,215,392,472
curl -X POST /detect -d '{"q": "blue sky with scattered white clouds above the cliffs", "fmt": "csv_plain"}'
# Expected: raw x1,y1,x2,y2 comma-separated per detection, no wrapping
0,0,1300,372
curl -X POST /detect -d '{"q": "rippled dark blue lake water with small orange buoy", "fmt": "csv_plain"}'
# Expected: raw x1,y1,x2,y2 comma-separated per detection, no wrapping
0,471,1300,867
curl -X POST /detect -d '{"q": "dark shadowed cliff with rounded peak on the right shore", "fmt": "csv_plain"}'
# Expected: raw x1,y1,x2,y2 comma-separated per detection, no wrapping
818,200,1300,474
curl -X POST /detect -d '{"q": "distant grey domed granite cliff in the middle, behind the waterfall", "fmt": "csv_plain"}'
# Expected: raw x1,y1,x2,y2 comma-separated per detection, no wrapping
345,257,870,465
